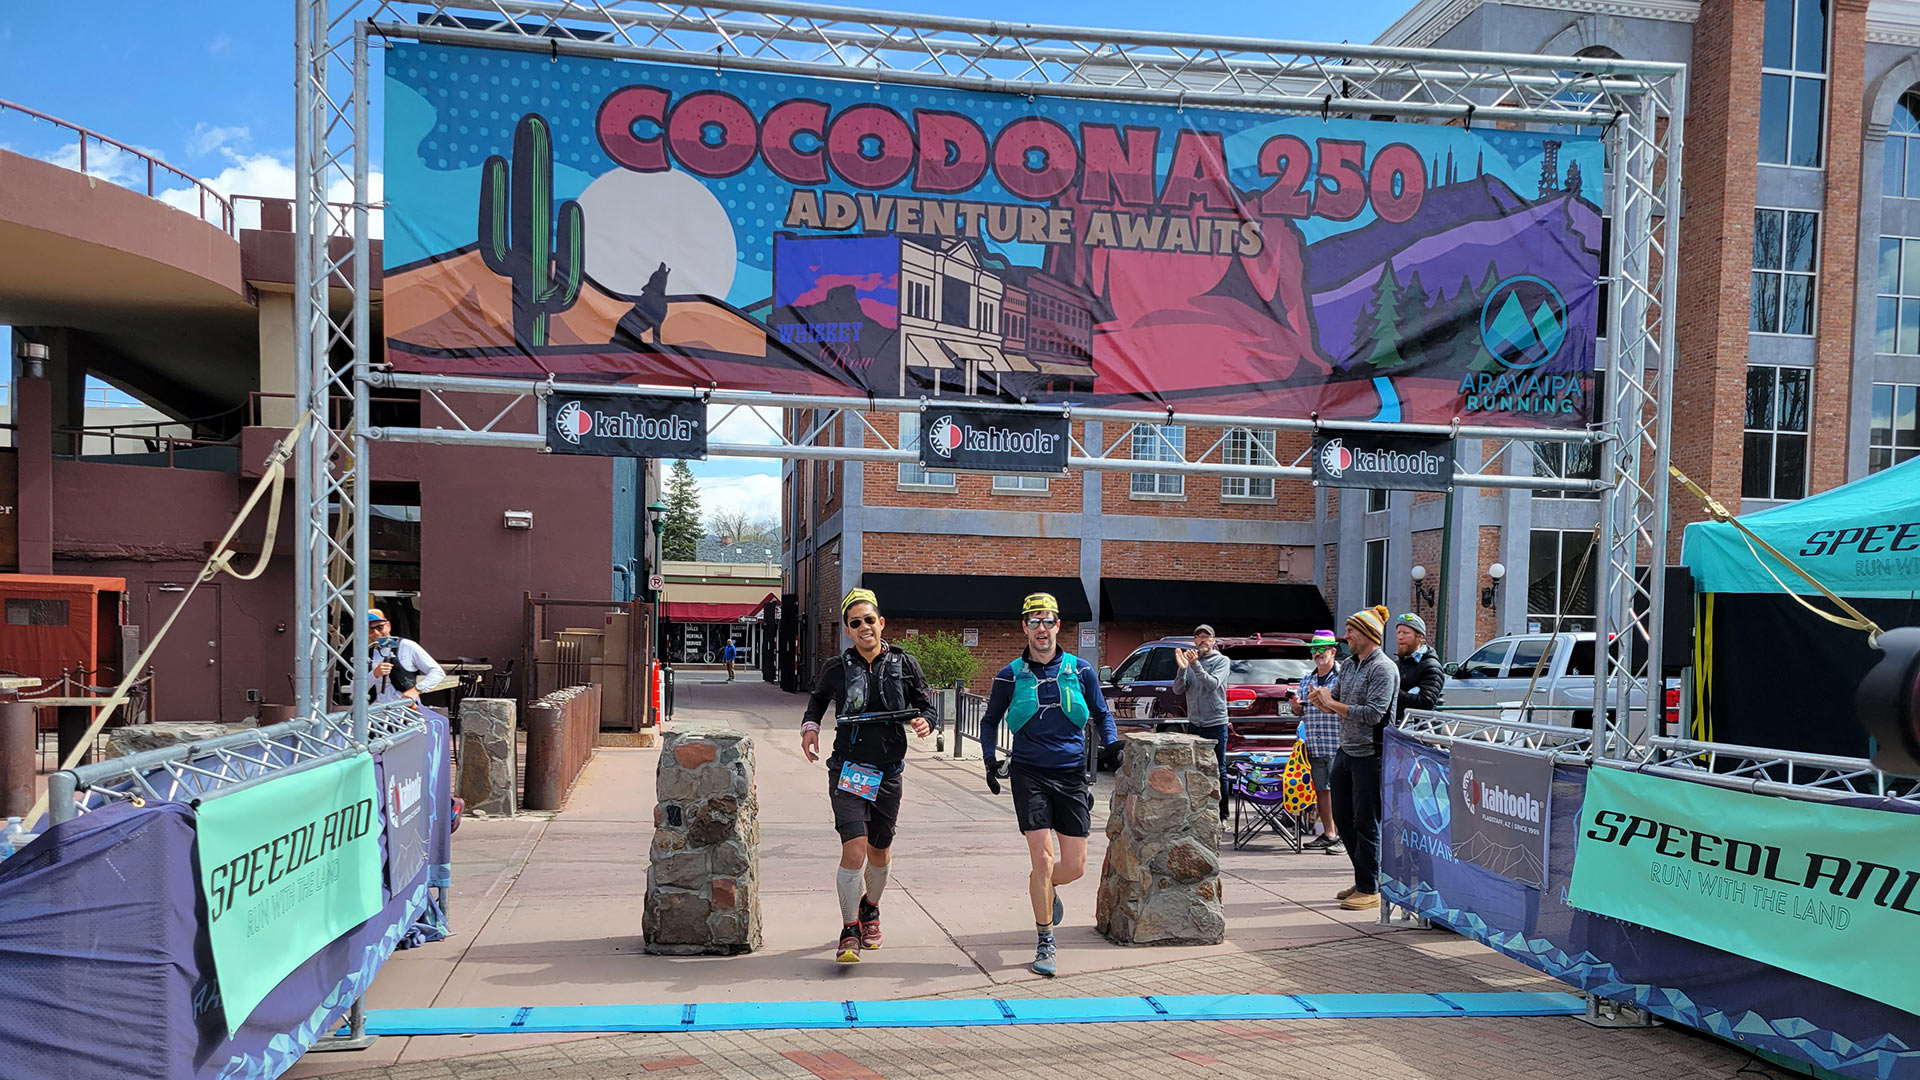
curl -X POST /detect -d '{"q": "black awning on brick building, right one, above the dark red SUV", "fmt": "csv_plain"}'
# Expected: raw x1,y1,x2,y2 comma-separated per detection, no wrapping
1100,578,1334,634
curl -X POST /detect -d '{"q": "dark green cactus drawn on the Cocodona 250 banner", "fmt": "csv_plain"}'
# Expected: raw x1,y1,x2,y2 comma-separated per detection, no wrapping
480,113,586,350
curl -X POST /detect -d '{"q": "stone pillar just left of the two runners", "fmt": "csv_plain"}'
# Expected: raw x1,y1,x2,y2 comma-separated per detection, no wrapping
641,721,760,955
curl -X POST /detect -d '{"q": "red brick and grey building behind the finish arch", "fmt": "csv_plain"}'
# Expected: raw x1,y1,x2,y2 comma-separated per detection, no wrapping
783,0,1920,684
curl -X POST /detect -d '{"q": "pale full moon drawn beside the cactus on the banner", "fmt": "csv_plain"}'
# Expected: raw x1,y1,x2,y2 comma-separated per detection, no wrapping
580,169,739,300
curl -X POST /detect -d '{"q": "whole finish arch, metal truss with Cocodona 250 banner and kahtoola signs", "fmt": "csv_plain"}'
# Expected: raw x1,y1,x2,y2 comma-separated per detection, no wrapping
270,0,1686,1045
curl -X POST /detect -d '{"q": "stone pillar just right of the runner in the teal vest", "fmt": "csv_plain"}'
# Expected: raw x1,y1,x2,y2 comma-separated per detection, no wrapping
1094,734,1227,945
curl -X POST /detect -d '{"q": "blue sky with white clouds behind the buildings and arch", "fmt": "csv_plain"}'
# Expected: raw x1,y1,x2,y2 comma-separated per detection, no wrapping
0,0,1411,519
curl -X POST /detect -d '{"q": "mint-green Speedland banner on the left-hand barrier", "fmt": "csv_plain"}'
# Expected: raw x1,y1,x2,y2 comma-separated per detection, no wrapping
196,753,384,1034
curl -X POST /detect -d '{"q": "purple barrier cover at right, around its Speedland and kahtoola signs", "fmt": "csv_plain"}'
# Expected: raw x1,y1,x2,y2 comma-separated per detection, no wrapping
1380,728,1920,1080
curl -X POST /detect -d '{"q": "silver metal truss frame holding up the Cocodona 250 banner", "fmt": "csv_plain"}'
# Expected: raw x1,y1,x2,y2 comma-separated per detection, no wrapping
296,0,1686,753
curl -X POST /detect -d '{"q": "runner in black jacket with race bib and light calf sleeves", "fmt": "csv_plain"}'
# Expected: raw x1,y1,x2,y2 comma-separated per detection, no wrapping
801,588,933,965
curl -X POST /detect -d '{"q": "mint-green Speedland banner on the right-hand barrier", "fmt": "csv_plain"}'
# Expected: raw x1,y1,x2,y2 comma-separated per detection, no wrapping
1567,769,1920,1013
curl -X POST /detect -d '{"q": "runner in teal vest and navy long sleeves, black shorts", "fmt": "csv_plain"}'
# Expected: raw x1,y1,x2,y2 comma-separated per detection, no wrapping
979,592,1119,976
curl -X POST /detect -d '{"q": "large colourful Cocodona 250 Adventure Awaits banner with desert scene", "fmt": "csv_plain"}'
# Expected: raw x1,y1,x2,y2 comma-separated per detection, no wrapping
384,42,1601,427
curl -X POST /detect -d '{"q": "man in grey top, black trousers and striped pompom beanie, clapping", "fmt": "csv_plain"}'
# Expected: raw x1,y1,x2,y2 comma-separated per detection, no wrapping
1309,607,1400,911
